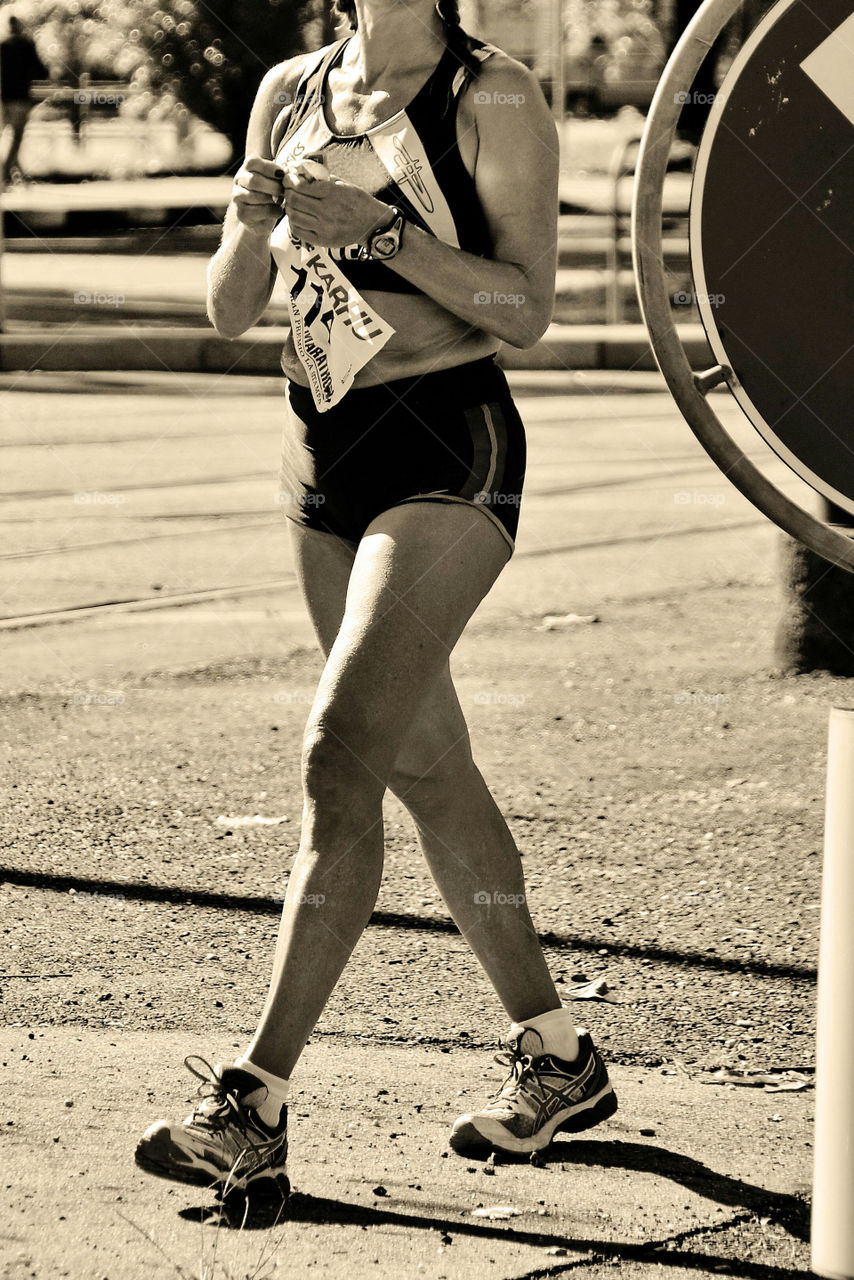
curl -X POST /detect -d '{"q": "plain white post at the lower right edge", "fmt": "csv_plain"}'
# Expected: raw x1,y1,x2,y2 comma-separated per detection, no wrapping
812,707,854,1280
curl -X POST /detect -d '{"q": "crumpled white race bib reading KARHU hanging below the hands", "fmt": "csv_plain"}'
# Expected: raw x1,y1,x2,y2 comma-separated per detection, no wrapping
270,215,394,413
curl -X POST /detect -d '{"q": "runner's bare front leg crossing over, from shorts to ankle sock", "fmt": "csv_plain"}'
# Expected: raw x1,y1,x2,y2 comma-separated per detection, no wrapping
247,503,517,1076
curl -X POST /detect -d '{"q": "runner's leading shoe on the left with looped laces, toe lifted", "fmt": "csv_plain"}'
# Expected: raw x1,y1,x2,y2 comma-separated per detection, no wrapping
136,1055,291,1201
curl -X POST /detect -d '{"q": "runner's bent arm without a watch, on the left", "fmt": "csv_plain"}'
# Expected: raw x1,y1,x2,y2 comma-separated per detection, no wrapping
207,58,303,338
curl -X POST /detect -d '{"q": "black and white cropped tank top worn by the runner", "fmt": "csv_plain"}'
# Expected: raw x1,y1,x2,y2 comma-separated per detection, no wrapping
270,36,495,293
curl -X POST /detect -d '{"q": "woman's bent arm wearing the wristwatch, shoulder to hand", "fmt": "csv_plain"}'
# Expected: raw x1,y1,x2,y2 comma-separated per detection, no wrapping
286,54,560,348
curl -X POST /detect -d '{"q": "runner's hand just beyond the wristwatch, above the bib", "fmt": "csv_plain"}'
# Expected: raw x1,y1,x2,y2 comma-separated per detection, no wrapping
284,164,391,248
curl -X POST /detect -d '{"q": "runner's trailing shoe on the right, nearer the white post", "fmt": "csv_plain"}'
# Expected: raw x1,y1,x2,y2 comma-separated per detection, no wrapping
451,1023,617,1155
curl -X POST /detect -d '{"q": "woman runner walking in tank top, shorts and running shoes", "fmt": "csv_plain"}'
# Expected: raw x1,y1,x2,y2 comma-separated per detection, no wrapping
137,0,616,1196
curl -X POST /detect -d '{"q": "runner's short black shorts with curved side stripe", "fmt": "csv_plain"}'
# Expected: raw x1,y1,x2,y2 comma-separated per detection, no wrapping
279,356,525,552
